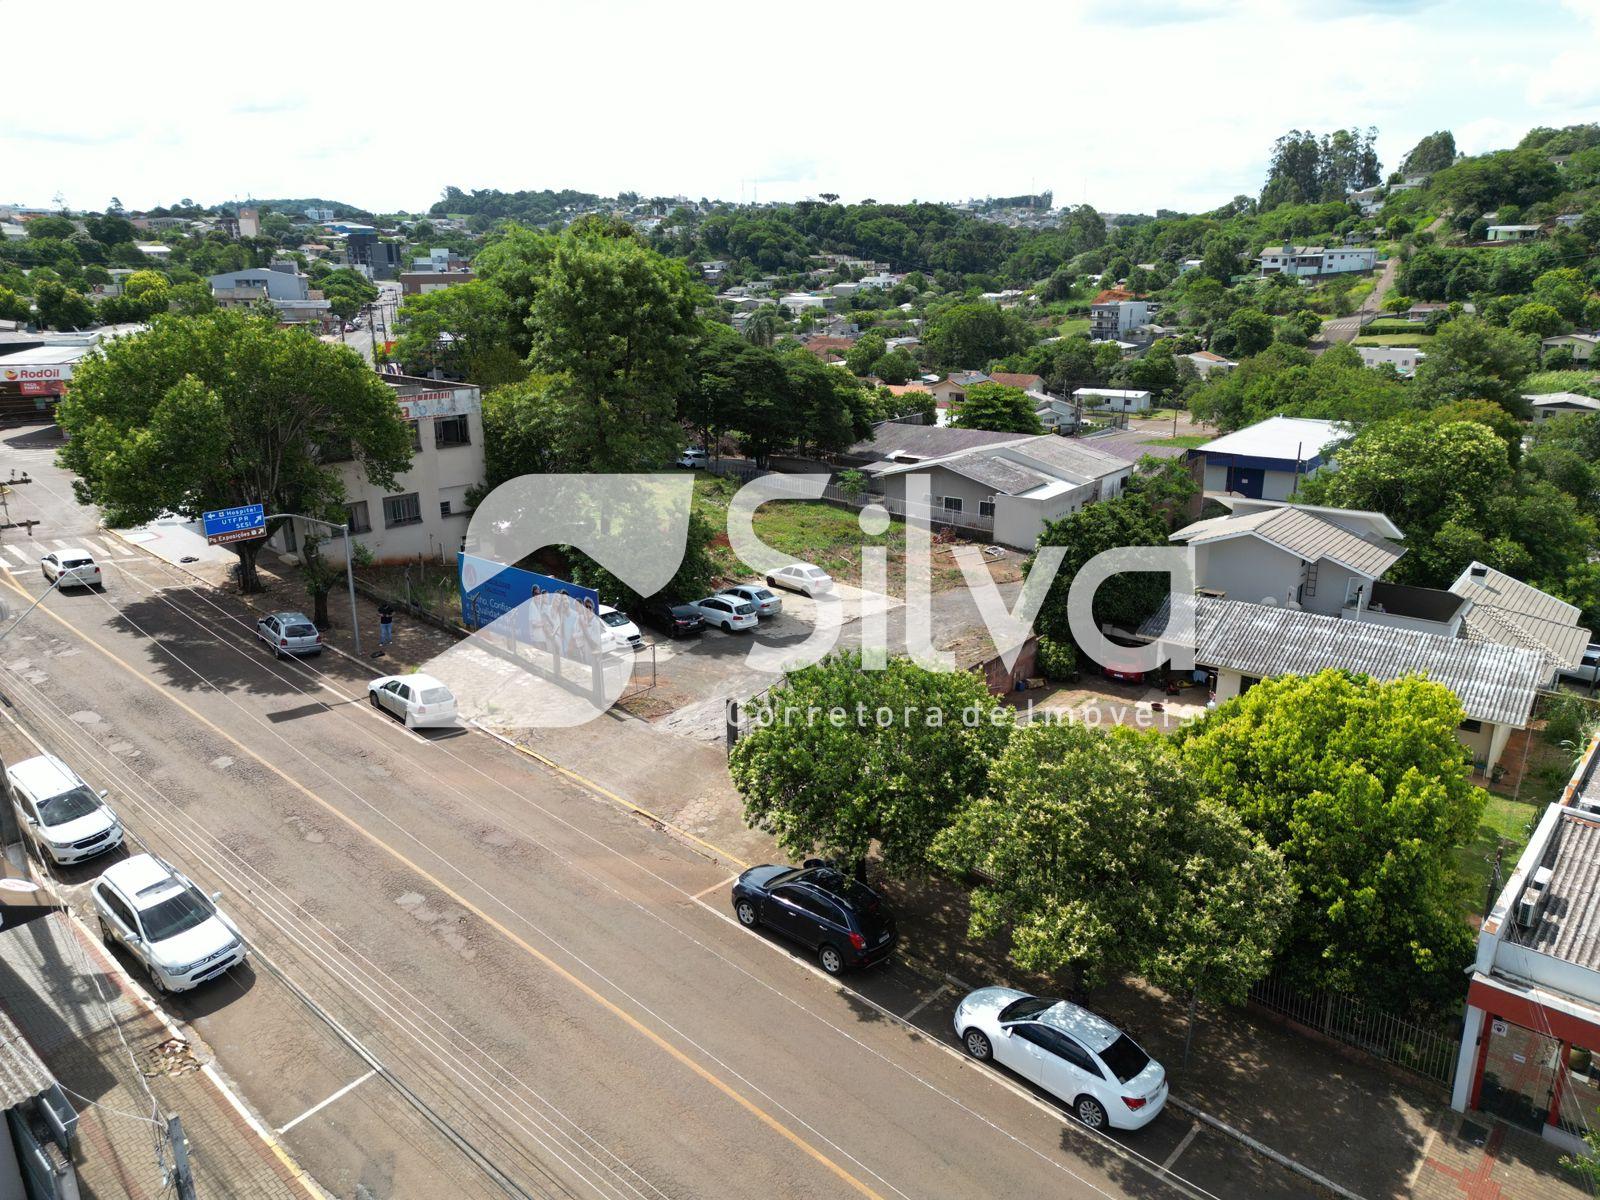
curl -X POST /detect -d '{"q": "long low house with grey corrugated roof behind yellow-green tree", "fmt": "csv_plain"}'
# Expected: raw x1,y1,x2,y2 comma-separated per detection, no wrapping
1139,595,1544,771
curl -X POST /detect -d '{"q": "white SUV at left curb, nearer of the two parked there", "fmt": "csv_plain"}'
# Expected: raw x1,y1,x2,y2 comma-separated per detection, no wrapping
90,854,250,992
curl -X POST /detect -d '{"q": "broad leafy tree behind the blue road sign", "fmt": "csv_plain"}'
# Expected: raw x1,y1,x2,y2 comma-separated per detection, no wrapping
58,310,411,590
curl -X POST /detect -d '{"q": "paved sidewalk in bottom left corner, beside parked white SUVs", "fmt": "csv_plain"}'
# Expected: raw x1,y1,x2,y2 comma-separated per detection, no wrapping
0,914,312,1200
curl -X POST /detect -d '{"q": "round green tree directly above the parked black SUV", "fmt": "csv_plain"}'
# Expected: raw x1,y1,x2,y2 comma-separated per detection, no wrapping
728,651,1011,874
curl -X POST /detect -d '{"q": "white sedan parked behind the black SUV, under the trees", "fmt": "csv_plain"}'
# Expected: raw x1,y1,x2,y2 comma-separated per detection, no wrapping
955,987,1166,1130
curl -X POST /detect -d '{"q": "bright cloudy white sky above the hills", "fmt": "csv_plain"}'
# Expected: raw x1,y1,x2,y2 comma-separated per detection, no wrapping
0,0,1600,219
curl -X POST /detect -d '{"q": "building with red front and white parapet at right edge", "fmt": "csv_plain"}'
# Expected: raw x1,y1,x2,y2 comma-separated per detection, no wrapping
1450,738,1600,1157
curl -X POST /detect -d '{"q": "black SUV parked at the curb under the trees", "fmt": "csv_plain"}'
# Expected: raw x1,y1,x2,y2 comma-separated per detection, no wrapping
733,859,898,974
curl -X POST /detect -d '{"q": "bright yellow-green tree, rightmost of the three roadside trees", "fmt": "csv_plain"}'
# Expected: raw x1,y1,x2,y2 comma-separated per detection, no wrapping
1179,670,1483,1008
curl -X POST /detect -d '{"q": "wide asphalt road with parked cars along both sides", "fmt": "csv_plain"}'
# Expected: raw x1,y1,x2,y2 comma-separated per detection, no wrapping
0,429,1306,1200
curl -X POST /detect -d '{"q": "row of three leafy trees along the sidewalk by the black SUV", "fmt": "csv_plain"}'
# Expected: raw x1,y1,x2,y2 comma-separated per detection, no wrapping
730,654,1482,1010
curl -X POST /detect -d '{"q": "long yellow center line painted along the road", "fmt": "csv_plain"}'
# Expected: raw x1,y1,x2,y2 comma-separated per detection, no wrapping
3,579,883,1200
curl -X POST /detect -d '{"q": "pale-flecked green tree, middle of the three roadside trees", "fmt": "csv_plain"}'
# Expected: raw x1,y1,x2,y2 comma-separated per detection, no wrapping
933,723,1288,1000
